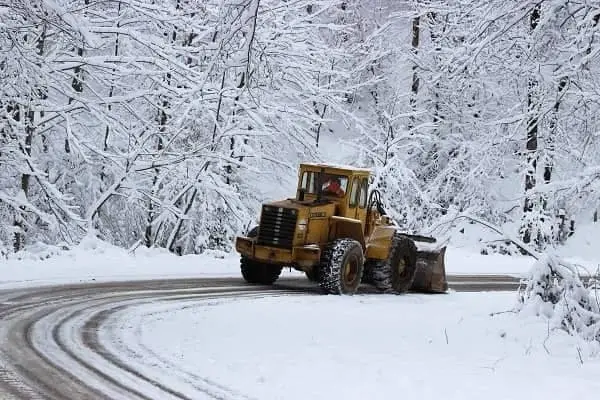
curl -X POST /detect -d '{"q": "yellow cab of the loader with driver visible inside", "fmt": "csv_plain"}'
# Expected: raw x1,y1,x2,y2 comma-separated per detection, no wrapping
296,164,370,222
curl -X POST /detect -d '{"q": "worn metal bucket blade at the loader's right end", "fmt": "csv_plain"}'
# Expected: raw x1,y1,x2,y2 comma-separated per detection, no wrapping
409,235,448,293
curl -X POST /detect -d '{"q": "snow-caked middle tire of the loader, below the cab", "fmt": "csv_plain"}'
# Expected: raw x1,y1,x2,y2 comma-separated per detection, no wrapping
319,239,364,294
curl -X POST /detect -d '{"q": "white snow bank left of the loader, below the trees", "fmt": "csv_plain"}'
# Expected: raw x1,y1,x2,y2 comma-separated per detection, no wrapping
0,237,239,287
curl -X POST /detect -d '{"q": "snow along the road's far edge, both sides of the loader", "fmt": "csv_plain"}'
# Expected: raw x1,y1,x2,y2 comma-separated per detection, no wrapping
0,229,600,288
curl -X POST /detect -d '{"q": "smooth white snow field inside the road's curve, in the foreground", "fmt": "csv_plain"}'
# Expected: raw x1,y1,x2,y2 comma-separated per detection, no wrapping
105,293,600,400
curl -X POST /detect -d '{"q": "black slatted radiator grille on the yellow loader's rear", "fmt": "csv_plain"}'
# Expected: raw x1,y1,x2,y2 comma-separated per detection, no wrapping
258,206,298,249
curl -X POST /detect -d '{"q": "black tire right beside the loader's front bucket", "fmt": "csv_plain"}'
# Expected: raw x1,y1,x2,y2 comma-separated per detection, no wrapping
373,234,417,293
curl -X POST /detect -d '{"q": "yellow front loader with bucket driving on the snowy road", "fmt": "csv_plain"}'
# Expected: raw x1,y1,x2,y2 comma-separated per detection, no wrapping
235,163,448,294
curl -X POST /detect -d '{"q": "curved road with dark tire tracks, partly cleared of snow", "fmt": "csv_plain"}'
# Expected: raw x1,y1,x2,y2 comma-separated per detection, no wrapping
0,275,518,400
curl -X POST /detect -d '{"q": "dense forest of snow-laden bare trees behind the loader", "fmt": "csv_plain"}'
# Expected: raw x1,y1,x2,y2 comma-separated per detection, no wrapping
0,0,600,254
